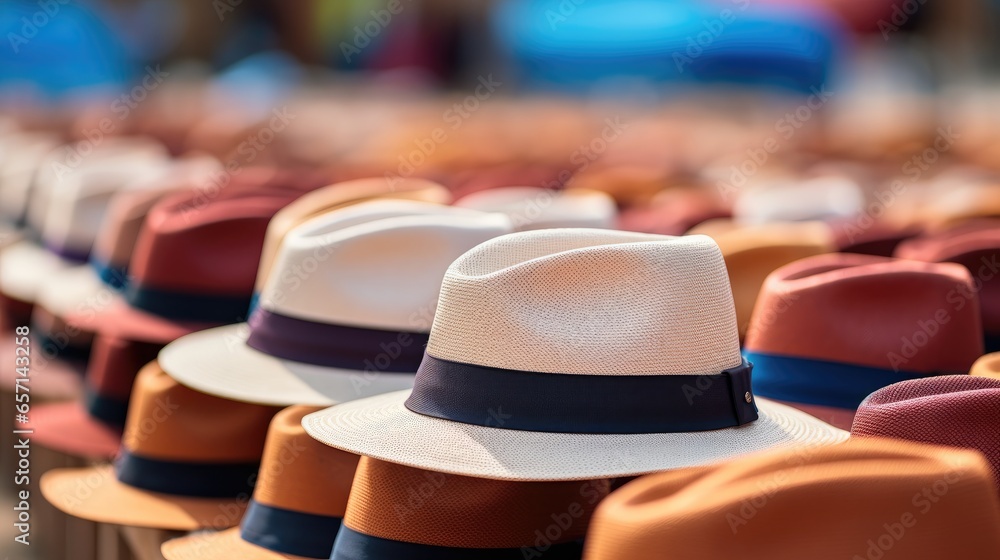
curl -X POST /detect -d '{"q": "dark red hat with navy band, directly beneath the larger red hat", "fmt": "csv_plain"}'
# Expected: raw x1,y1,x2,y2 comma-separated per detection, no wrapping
32,335,163,459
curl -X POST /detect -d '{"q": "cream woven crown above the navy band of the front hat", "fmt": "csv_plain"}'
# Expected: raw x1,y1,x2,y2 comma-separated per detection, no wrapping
427,229,741,375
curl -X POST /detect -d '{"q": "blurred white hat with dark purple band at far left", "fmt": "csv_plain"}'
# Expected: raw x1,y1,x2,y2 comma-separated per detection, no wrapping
0,140,169,302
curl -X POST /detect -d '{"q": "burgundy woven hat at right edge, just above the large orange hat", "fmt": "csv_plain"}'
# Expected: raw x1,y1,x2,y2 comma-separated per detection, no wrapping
851,375,1000,492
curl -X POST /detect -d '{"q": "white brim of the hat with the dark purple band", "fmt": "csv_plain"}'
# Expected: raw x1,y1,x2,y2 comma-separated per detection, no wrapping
158,323,416,406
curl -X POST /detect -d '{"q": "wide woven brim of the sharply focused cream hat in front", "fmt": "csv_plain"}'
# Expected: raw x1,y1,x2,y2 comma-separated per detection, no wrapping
302,391,848,481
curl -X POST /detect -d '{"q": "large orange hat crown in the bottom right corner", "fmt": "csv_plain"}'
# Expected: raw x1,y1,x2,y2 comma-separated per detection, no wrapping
584,440,1000,560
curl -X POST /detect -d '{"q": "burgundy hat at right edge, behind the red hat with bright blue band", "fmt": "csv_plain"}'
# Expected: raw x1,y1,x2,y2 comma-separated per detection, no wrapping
896,220,1000,352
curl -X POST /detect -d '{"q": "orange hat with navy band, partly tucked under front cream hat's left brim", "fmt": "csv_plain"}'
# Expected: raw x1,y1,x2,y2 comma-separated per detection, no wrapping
163,406,360,560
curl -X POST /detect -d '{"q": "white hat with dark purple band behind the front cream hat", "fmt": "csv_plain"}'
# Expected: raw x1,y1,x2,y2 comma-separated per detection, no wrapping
159,200,512,406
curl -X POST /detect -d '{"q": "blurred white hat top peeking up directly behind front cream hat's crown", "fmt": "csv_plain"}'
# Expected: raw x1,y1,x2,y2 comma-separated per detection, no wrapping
455,187,618,231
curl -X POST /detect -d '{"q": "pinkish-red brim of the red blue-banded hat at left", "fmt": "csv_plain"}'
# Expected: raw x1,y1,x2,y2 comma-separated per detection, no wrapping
65,294,216,344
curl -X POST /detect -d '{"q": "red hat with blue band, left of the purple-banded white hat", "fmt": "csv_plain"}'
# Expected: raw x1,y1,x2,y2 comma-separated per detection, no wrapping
66,170,316,344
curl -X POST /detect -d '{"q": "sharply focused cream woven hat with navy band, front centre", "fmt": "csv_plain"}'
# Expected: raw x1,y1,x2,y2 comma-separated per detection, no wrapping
303,229,847,480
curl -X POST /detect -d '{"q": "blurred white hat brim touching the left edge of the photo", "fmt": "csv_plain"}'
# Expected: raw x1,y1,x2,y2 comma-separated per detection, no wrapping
0,240,74,303
